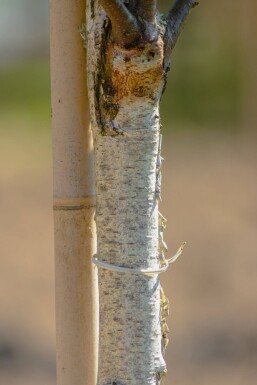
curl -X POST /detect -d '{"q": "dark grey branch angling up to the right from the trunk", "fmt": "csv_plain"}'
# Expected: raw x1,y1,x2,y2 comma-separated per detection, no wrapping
166,0,199,52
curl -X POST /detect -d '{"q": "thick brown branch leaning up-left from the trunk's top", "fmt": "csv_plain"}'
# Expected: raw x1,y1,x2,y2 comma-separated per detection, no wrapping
100,0,141,45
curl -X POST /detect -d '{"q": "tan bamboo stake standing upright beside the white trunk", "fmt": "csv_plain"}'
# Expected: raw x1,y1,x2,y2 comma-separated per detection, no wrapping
50,0,98,385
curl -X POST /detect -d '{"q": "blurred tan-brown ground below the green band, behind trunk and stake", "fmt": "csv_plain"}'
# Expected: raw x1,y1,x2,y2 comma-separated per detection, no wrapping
0,129,257,385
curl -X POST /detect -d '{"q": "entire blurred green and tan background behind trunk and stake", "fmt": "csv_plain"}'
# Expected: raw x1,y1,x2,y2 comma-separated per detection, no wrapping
0,0,257,385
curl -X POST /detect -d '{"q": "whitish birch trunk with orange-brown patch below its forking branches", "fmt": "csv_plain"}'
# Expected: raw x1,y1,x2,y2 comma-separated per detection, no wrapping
83,0,196,385
